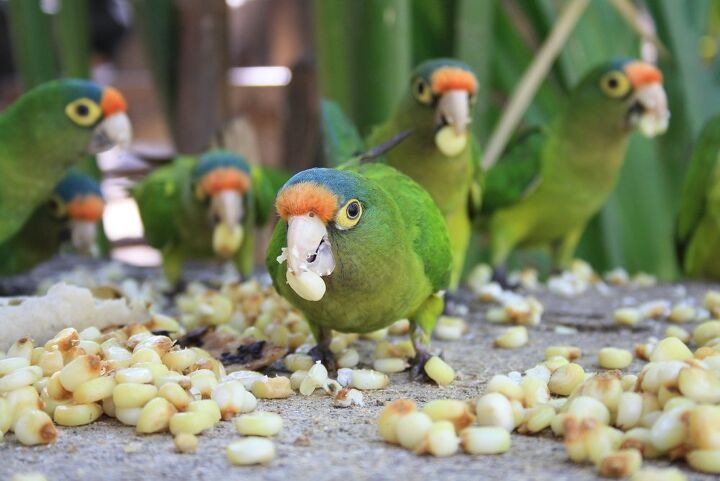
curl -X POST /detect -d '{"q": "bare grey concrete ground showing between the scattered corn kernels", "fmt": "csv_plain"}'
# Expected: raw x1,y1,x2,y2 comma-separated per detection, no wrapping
0,274,720,481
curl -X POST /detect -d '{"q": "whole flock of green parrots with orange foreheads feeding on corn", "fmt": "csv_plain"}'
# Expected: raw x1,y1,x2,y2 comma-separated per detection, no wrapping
0,59,720,364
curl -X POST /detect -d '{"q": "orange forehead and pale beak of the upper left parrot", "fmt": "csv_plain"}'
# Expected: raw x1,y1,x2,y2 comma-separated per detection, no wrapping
88,87,132,154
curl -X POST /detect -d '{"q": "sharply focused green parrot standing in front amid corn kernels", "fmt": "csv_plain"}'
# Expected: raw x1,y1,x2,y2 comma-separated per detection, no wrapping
266,163,452,374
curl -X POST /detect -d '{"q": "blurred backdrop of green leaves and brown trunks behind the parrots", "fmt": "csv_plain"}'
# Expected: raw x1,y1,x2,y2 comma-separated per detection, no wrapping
0,0,720,279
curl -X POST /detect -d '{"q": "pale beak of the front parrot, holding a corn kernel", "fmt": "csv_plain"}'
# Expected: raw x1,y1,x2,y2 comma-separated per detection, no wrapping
278,214,335,301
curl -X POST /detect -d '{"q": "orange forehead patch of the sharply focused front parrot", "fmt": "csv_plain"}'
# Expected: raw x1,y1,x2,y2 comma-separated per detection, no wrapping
275,182,338,223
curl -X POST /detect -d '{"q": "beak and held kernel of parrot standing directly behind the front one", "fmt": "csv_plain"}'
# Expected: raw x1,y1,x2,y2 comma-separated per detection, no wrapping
435,90,471,157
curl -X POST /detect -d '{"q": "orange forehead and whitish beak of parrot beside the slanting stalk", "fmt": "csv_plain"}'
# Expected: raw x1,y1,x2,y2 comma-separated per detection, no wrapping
625,62,670,137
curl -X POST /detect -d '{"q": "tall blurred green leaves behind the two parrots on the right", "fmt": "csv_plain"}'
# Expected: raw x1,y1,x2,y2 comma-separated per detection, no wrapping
315,0,720,279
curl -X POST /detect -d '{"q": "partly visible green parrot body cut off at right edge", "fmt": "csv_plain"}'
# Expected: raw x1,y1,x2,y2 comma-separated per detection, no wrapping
677,115,720,279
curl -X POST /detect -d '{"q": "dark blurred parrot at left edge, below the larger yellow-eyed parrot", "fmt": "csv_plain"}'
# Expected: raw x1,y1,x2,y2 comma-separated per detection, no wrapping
0,168,105,275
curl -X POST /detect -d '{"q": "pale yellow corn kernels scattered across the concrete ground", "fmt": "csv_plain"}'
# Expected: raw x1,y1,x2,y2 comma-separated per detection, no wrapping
0,262,720,480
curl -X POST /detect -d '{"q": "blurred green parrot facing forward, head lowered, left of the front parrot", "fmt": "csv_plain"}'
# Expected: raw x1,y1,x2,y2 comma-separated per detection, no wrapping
131,150,289,284
